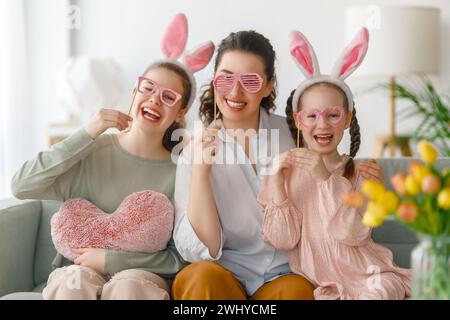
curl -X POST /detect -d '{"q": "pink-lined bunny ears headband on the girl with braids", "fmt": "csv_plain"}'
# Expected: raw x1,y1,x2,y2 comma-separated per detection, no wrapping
290,28,369,112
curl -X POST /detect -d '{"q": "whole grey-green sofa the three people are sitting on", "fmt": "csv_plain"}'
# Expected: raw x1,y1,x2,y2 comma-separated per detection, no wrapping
0,158,450,299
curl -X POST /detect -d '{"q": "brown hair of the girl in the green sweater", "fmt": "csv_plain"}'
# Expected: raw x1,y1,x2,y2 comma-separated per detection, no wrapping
143,62,192,151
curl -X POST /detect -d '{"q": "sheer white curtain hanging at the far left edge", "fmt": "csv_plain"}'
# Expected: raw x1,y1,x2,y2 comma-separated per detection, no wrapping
0,0,33,198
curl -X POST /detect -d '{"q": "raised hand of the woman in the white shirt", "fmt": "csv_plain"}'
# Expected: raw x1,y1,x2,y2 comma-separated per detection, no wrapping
192,124,221,175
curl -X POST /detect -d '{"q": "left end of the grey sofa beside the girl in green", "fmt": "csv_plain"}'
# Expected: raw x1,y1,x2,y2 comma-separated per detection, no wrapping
0,199,60,297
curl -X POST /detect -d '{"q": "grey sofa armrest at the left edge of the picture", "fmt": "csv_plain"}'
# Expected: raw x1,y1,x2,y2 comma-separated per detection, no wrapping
0,199,41,297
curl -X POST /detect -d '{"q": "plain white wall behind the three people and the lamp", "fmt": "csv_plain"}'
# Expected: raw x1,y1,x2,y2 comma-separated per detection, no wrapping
28,0,450,156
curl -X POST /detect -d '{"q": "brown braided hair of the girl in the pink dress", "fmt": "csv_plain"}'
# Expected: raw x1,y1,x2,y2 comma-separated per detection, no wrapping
286,82,361,179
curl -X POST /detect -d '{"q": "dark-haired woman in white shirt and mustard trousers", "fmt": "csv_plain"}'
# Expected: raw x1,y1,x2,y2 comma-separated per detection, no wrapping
172,31,313,299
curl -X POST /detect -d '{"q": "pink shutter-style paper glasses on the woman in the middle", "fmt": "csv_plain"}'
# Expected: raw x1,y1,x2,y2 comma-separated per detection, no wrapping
213,73,263,95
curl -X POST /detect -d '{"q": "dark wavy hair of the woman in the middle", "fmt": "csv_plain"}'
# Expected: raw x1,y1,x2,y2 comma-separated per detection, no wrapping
199,31,277,125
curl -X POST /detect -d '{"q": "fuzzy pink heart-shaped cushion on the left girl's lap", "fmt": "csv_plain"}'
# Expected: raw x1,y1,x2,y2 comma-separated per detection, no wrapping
50,191,174,260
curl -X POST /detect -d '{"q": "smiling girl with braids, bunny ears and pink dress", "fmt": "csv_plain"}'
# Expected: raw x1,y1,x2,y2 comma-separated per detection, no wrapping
258,29,410,299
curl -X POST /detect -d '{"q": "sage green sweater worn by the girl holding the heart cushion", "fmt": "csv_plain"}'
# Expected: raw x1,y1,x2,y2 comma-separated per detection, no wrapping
11,129,186,277
